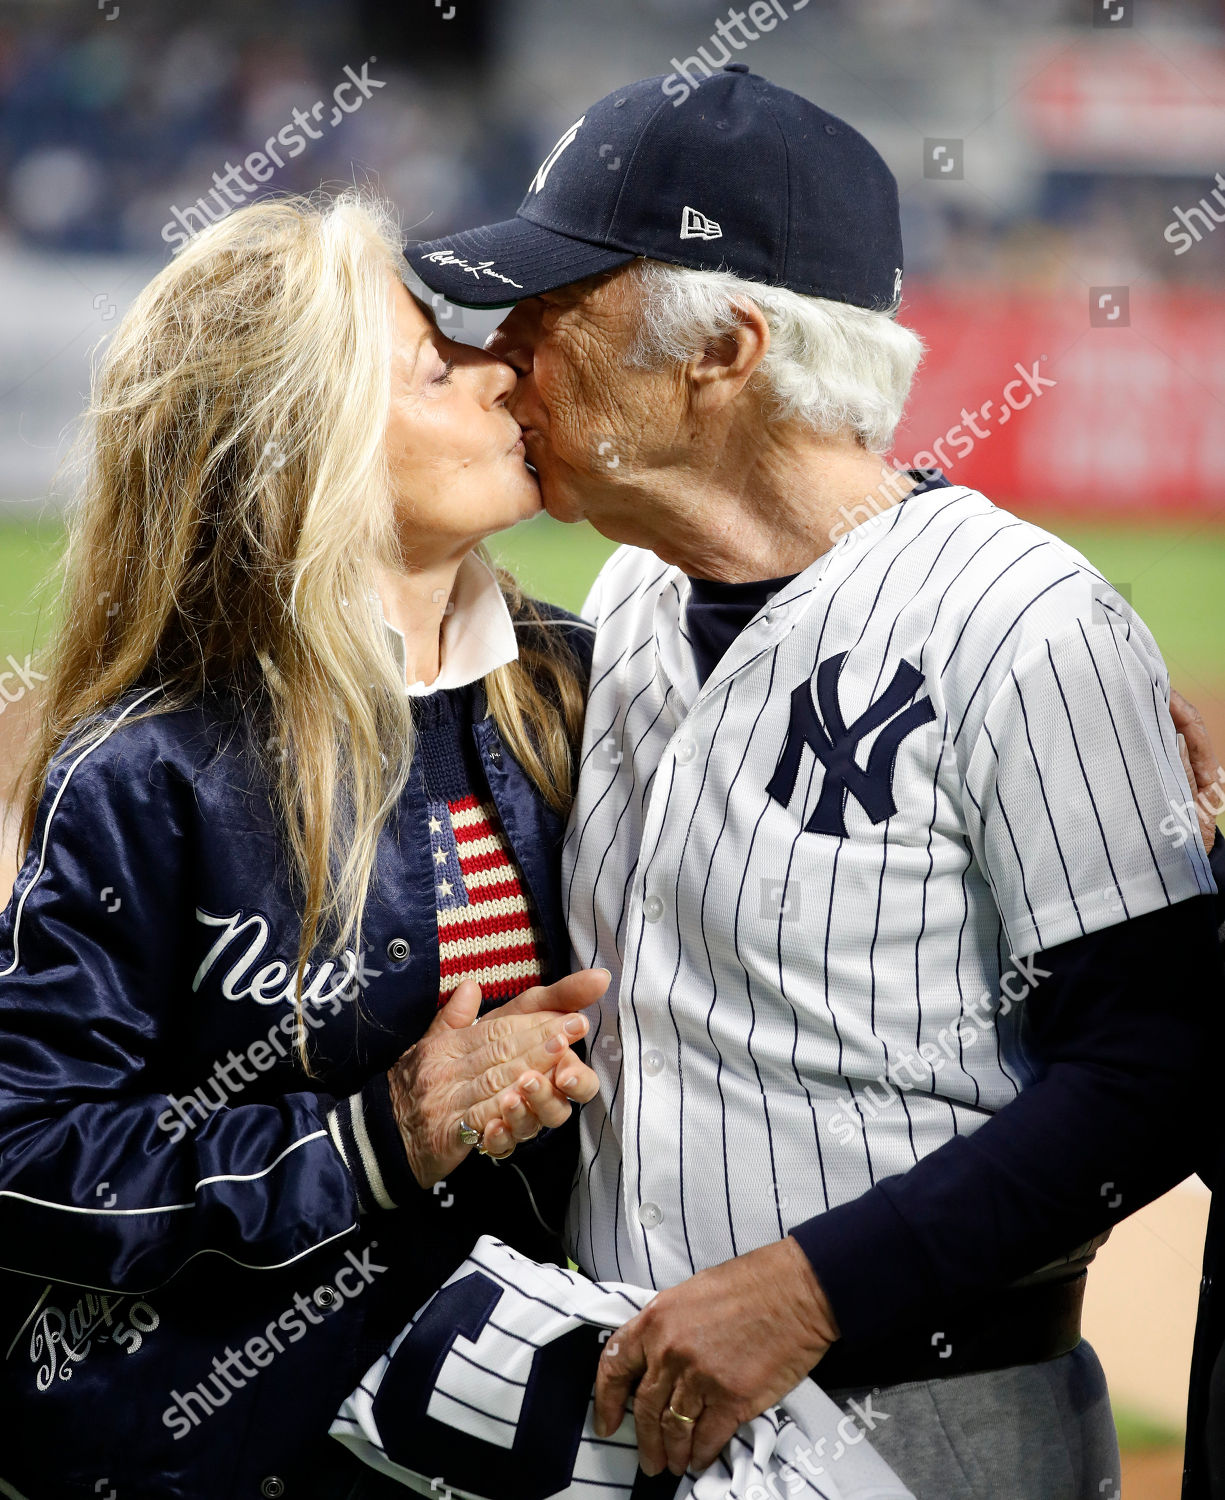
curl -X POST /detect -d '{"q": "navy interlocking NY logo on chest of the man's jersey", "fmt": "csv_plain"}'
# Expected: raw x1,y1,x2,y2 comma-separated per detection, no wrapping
766,651,936,839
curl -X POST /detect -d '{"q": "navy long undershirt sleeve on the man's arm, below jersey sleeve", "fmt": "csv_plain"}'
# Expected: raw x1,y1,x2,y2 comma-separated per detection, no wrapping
792,860,1225,1337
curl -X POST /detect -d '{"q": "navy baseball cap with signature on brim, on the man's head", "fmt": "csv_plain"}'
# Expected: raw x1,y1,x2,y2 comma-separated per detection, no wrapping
405,63,903,311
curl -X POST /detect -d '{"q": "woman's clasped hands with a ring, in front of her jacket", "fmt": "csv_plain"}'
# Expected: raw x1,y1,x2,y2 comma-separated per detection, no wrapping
387,969,610,1188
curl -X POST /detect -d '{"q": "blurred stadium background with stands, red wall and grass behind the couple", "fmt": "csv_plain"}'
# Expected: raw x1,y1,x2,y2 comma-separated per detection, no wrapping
0,0,1225,1482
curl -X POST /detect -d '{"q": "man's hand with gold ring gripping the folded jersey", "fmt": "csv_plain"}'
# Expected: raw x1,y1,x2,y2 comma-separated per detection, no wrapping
595,1236,838,1475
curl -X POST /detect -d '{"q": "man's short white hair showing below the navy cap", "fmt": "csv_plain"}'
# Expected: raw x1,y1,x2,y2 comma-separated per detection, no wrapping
630,260,924,453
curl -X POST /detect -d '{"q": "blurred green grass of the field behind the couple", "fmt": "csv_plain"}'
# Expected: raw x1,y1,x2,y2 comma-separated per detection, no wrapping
0,516,1225,707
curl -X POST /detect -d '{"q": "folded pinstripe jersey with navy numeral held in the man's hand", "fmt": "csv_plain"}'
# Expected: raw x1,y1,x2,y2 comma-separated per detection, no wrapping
331,1235,913,1500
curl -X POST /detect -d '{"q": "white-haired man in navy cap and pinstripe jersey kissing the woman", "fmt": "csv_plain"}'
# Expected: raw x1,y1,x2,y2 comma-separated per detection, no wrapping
406,63,1221,1500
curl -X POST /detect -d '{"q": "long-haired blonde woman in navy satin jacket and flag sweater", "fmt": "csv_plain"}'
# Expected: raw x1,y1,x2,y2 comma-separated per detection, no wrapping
0,194,607,1500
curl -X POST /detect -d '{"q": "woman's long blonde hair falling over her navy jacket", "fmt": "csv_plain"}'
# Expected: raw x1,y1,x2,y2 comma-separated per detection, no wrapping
21,189,583,1067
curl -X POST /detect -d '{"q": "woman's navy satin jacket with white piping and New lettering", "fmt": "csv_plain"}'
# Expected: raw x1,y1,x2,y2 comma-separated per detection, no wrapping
0,606,589,1500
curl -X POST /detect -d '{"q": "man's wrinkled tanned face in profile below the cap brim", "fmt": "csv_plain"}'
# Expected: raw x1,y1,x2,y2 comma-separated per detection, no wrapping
486,267,684,536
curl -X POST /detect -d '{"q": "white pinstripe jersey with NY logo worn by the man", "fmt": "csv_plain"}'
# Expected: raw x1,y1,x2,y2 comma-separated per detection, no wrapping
564,486,1215,1287
